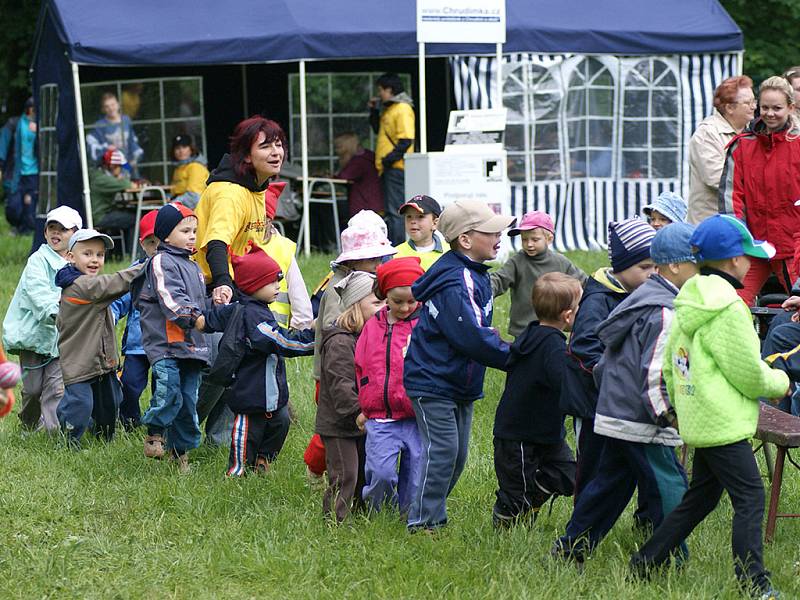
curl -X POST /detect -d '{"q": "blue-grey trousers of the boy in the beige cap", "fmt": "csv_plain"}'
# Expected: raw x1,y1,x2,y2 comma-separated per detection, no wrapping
408,398,473,530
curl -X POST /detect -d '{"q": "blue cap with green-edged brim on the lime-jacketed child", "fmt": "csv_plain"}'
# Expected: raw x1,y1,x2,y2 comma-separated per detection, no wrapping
690,215,775,261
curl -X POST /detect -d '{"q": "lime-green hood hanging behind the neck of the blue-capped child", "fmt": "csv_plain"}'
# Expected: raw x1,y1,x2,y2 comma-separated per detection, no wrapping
675,275,742,336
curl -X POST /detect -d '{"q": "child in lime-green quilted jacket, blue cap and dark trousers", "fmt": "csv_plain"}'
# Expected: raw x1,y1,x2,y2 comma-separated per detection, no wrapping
631,215,789,598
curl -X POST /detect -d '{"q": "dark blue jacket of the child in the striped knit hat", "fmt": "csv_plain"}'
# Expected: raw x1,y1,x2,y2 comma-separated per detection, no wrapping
561,269,628,419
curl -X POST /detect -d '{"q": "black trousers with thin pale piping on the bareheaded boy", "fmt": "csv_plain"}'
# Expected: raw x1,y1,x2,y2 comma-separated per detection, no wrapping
494,438,575,519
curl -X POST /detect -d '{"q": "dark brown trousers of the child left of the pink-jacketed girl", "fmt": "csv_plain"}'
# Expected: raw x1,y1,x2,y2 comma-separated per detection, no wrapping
322,435,366,523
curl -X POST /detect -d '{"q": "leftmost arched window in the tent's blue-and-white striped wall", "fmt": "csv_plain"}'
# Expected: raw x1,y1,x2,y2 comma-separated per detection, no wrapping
503,63,564,182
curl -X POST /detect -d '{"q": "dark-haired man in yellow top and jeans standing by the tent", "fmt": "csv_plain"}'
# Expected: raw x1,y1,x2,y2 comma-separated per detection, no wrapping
369,73,416,245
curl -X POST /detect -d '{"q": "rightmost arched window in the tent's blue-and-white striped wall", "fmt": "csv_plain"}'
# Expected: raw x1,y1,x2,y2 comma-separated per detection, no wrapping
620,58,680,179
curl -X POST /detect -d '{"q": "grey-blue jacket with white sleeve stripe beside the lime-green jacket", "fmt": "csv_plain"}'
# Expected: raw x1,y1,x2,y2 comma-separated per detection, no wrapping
594,275,682,446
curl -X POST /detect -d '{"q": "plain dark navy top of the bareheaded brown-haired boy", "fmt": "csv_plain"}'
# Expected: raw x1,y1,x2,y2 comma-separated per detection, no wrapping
494,321,567,444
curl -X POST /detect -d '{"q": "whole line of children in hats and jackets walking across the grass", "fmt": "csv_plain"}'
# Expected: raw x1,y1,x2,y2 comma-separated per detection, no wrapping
4,185,789,596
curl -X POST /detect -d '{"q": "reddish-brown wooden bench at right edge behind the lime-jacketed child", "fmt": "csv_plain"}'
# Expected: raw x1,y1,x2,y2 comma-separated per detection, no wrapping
755,403,800,542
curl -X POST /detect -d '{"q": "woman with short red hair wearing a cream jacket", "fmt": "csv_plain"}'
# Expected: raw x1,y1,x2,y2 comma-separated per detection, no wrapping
687,75,756,224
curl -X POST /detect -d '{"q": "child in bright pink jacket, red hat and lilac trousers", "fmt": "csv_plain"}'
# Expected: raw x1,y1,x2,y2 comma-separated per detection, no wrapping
355,256,424,514
